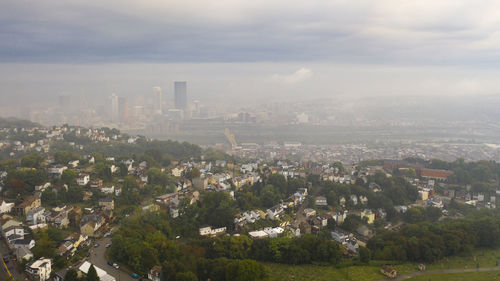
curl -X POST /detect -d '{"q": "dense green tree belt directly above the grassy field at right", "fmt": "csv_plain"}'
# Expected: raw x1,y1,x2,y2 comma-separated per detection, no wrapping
367,211,500,262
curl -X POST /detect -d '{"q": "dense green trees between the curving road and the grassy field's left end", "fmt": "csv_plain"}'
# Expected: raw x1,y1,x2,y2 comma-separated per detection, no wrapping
110,213,266,280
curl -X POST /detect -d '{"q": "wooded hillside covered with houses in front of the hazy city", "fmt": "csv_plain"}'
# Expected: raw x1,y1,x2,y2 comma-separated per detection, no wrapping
0,124,500,281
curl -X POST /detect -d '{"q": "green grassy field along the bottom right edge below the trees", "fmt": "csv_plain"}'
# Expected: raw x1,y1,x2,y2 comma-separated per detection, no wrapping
266,249,500,281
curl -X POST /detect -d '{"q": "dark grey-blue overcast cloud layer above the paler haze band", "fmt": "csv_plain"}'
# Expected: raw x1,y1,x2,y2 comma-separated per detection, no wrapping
0,0,500,64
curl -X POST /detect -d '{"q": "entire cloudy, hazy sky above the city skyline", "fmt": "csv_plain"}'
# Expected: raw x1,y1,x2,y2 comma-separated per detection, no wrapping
0,0,500,103
